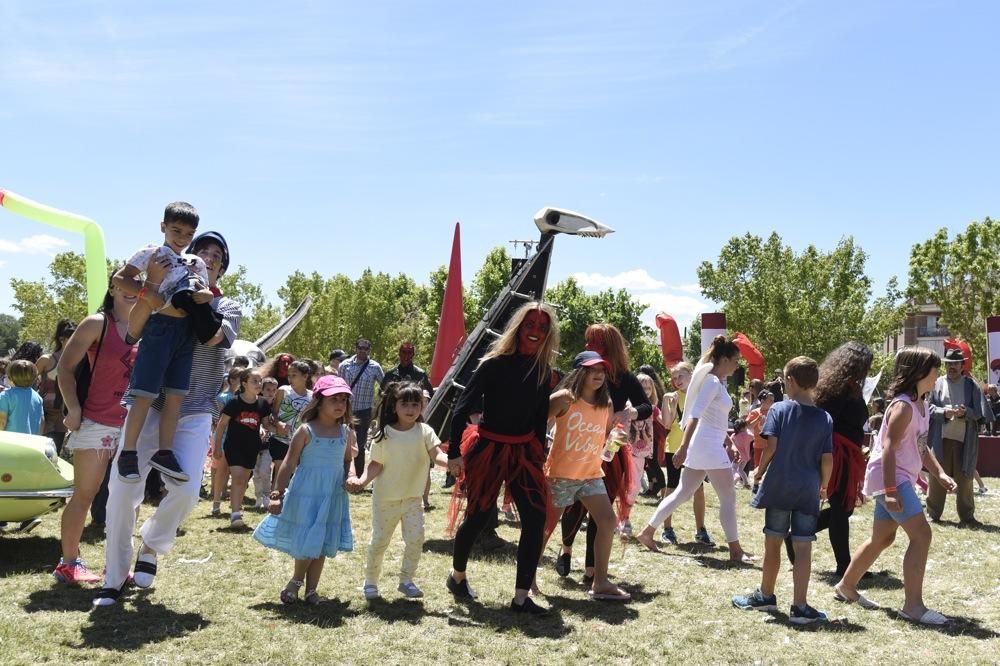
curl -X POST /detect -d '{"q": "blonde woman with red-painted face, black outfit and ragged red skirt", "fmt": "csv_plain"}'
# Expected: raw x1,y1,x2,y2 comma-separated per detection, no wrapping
448,303,559,615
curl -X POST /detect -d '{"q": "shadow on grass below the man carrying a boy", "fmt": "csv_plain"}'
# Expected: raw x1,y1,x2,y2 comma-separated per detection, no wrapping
75,590,210,652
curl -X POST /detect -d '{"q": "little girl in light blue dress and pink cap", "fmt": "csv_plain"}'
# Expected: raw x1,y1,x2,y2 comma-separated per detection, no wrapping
253,375,357,604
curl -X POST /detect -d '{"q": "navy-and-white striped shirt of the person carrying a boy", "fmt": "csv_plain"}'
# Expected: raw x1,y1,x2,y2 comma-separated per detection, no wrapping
124,296,243,418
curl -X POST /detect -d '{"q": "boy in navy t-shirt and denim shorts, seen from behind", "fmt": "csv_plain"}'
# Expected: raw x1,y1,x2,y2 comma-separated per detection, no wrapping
733,356,833,624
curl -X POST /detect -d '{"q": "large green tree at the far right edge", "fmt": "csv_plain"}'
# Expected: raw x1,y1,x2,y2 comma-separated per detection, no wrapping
907,217,1000,376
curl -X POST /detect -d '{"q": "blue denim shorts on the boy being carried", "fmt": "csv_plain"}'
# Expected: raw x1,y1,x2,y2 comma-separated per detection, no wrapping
129,314,194,398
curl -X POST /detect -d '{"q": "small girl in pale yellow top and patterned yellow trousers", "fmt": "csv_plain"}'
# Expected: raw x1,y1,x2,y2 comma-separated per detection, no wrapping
347,382,448,601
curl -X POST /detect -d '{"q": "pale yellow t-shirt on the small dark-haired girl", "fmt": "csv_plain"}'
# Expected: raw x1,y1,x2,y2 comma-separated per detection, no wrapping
370,423,441,500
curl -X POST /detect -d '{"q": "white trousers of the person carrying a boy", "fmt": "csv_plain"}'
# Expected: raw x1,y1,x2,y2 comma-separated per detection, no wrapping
104,409,212,588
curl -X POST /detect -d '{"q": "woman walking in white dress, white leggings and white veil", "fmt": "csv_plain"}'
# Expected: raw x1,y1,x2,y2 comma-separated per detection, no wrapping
637,335,750,562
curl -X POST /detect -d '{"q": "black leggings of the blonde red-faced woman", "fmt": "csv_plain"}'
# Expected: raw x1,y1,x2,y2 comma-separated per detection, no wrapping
451,445,545,590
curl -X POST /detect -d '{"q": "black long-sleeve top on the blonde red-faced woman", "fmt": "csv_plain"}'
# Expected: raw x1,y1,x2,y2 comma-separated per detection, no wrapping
448,355,552,458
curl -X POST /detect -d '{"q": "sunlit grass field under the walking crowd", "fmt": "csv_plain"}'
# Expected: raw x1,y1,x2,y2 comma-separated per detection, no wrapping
0,470,1000,664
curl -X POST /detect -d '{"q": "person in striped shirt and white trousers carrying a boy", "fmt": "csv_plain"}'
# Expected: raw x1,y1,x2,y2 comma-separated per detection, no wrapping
94,231,242,606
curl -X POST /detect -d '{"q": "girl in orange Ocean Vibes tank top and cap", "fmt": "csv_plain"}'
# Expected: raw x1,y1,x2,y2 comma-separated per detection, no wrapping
542,351,632,601
